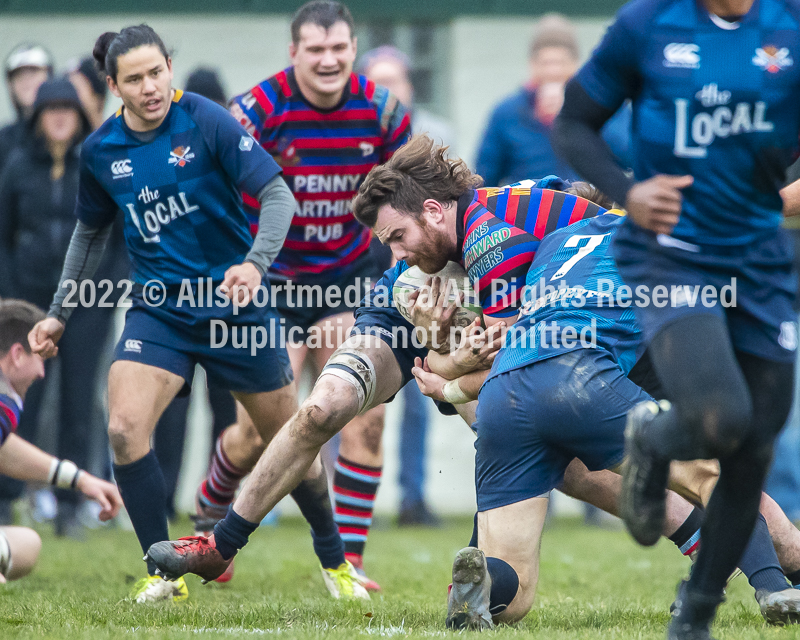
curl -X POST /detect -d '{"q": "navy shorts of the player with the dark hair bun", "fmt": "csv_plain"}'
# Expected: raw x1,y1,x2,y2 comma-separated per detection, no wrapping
114,288,293,395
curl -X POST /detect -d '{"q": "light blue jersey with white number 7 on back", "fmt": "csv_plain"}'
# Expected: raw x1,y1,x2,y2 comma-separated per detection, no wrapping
491,212,641,376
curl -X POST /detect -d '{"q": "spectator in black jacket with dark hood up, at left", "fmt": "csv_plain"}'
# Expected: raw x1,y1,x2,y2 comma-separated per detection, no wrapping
0,78,124,535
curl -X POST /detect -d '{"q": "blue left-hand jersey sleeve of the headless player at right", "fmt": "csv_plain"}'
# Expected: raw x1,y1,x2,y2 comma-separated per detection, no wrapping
577,5,641,111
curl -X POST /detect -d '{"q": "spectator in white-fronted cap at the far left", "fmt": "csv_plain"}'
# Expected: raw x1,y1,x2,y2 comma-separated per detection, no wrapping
0,44,53,171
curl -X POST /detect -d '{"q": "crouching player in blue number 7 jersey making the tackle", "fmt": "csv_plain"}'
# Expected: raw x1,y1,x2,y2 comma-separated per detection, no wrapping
406,212,800,629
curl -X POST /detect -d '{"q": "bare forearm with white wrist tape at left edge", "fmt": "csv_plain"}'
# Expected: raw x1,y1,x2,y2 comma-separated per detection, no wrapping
0,433,122,521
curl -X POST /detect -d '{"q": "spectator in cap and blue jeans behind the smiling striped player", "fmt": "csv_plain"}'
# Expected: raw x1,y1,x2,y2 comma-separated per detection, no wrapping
359,46,446,527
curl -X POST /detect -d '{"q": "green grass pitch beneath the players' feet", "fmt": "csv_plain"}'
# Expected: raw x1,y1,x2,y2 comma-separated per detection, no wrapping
0,519,800,640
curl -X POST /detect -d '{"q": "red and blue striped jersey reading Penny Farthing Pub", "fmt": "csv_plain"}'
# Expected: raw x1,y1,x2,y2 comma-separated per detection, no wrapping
231,68,410,280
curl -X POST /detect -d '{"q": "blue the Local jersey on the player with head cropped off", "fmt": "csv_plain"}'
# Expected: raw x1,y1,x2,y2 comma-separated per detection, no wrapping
577,0,800,245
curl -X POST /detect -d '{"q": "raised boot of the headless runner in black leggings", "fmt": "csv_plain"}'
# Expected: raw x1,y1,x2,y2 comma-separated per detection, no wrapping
619,400,670,547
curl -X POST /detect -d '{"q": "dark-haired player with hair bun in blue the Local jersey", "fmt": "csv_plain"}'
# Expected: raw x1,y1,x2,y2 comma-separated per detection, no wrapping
25,25,368,602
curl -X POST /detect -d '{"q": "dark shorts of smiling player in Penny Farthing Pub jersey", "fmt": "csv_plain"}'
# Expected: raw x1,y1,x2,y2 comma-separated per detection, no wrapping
270,251,382,341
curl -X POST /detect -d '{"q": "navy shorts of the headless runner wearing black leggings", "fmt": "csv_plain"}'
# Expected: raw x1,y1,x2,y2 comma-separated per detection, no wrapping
612,221,797,362
